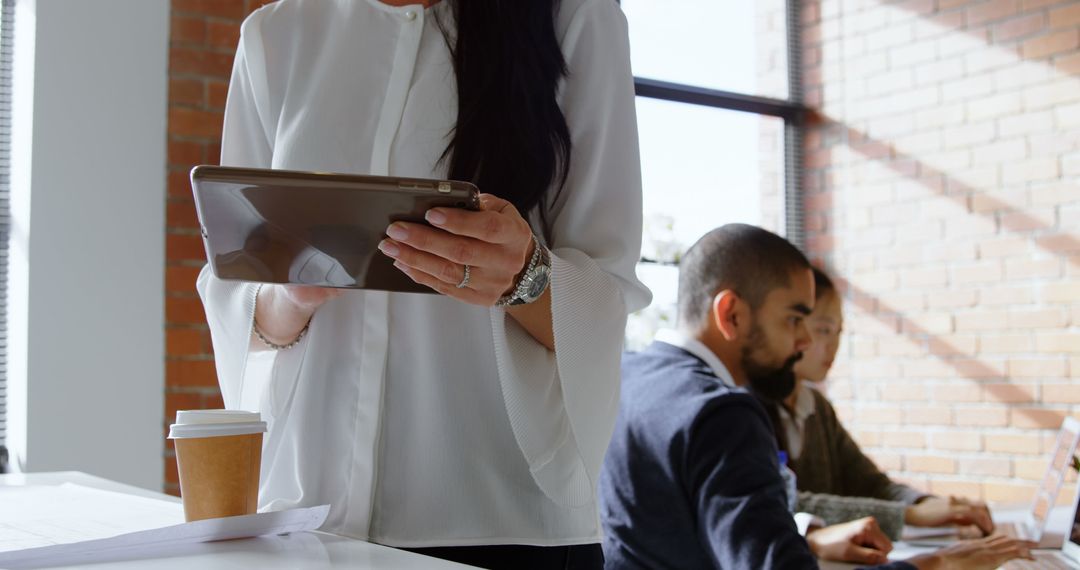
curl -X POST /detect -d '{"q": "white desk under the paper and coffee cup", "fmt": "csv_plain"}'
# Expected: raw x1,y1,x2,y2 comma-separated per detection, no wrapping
0,472,471,570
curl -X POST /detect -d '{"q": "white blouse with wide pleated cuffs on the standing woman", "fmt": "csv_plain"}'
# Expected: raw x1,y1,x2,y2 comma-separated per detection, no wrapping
199,0,649,547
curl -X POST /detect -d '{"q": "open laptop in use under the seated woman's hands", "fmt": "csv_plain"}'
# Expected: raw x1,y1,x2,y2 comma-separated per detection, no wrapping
903,417,1080,548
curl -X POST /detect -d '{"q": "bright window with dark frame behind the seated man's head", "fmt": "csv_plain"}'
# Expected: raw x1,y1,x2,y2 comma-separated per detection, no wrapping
621,0,804,350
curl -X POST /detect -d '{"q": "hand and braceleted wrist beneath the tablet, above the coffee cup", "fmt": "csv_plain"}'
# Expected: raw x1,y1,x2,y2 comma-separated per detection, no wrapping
252,284,343,347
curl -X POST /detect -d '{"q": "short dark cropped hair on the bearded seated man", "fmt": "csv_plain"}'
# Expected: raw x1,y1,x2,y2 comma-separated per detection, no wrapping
678,223,811,328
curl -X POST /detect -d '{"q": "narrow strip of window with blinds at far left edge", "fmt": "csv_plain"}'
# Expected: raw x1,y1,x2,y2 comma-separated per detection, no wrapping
0,0,15,473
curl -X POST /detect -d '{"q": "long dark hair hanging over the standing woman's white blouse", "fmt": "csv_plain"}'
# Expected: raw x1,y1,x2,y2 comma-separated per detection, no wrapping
440,0,570,240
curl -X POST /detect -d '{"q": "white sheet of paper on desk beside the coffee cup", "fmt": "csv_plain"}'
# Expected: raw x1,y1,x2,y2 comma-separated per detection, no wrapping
0,484,329,569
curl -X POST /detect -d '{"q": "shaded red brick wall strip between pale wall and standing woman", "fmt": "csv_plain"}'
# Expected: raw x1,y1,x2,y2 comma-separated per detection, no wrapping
164,0,274,493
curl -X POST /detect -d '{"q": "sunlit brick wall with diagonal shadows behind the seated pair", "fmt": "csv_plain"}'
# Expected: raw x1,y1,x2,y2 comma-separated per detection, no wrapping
802,0,1080,502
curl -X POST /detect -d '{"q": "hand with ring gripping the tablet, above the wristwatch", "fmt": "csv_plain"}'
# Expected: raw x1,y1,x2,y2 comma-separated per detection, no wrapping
379,194,534,307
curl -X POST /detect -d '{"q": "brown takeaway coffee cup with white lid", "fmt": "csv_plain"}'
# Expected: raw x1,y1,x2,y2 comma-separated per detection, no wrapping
168,410,267,523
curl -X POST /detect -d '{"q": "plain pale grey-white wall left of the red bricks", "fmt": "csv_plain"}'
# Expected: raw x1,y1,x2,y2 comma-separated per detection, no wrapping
9,0,170,489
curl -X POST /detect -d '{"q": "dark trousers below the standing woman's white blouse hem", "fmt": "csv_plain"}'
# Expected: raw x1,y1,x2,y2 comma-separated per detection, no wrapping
403,544,604,570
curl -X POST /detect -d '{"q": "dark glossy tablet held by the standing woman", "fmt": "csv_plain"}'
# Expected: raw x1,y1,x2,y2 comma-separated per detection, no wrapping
191,165,480,293
